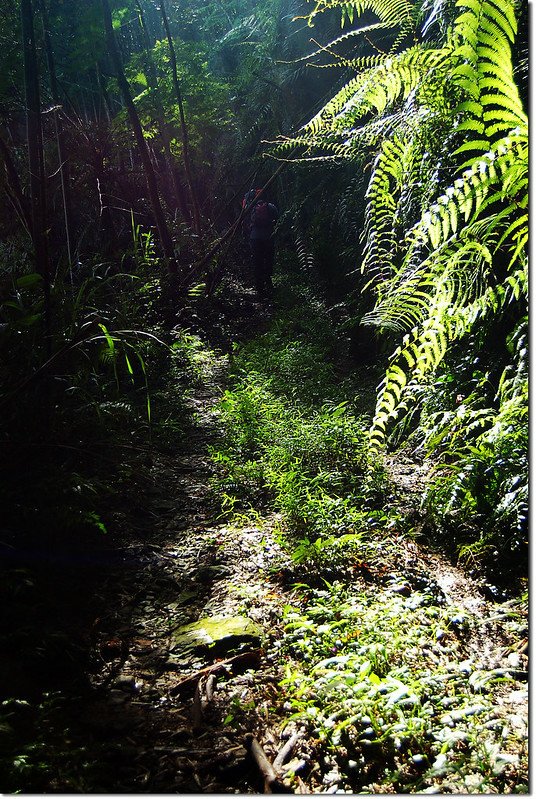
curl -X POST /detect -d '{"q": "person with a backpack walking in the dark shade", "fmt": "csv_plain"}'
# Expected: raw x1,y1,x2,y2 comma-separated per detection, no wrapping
243,189,278,296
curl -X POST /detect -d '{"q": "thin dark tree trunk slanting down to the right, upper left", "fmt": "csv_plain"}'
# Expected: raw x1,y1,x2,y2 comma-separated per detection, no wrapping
101,0,178,278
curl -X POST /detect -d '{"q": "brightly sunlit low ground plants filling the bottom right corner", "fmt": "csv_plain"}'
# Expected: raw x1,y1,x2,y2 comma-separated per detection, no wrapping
276,574,528,793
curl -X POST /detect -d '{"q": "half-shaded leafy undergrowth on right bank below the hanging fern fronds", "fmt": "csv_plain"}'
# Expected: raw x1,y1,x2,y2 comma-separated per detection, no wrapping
393,319,529,590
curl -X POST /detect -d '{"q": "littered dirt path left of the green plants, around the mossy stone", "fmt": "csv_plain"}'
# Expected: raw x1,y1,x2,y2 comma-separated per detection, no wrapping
58,308,298,793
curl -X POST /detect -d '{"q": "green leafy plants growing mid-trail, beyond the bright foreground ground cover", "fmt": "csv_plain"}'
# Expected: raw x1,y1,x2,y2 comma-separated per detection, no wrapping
212,280,386,560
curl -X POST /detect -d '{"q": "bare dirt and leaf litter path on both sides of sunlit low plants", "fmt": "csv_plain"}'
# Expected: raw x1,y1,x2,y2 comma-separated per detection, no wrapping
51,332,526,793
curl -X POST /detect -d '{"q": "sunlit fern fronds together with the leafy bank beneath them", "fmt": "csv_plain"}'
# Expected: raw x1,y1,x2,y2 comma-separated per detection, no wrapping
268,1,528,576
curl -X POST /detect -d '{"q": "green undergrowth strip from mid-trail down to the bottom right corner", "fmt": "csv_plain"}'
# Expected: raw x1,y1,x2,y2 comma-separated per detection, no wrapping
209,268,527,793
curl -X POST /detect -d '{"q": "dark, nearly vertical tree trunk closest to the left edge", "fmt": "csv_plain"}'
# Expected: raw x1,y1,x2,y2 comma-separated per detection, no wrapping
21,0,51,340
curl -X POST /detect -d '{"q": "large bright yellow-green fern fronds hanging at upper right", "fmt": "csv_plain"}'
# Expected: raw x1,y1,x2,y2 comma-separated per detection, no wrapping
279,0,528,447
